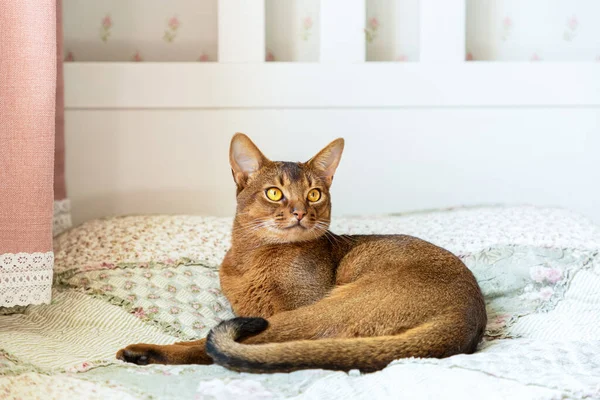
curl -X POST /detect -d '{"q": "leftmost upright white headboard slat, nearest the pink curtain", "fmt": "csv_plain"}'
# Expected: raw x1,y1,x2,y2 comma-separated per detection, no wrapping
218,0,265,63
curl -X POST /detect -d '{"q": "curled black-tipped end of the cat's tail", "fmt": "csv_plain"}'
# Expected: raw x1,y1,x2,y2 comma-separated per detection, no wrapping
206,317,269,364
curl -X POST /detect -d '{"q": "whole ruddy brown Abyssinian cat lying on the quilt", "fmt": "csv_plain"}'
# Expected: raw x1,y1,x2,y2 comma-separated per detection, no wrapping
117,134,487,372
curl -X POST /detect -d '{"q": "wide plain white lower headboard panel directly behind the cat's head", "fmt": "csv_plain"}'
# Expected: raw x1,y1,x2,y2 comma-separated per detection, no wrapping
65,107,600,224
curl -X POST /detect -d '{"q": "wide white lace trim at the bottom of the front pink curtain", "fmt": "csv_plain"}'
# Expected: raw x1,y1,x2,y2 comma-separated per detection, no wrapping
0,251,54,307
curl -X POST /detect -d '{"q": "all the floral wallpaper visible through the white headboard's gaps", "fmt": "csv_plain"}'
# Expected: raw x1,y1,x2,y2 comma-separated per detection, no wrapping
63,0,600,62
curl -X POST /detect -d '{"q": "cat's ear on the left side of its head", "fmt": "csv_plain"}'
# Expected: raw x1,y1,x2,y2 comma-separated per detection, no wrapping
229,133,269,189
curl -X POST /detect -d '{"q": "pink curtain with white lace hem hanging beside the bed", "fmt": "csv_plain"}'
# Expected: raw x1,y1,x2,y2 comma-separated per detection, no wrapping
0,0,65,307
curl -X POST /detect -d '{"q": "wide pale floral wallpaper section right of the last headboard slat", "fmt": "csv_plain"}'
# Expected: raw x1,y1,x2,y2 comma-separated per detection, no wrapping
466,0,600,62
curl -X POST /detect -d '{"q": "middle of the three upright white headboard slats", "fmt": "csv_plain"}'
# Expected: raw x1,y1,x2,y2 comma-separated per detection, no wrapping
320,0,366,63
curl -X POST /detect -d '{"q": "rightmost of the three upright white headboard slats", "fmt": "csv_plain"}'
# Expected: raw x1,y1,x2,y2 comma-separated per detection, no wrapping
419,0,466,63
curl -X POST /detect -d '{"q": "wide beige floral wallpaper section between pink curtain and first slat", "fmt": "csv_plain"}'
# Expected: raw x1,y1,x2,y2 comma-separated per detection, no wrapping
63,0,218,62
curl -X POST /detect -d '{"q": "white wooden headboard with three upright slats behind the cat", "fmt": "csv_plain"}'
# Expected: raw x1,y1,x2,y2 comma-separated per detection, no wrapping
65,0,600,223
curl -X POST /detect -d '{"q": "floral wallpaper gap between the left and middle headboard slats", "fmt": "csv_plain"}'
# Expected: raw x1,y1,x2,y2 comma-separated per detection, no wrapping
265,0,321,62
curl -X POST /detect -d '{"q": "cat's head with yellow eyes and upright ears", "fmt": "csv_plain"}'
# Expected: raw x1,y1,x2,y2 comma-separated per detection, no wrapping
229,133,344,243
